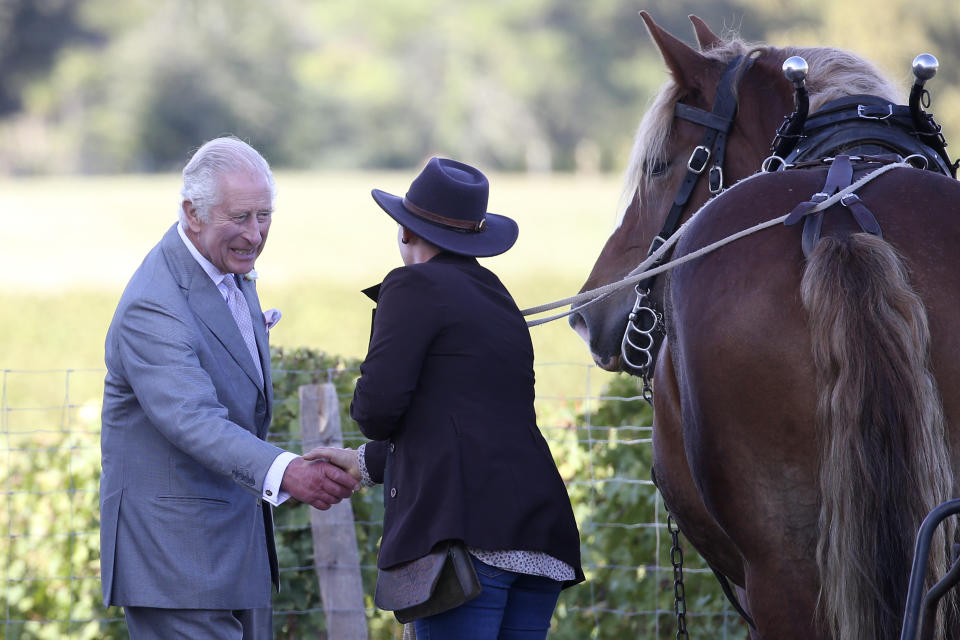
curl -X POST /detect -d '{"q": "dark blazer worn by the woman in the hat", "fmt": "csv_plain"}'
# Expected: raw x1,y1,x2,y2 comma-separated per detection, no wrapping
350,253,583,584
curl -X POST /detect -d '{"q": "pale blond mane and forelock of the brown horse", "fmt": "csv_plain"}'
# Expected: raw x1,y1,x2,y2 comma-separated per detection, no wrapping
617,36,905,225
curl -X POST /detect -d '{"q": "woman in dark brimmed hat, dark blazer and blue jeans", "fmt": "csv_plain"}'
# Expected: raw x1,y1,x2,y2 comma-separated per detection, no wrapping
316,158,584,640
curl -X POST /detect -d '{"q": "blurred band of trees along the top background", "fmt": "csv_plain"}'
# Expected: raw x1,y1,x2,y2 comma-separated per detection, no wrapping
0,0,960,173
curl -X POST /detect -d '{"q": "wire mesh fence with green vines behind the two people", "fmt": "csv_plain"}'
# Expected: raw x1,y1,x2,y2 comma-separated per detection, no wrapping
0,362,746,639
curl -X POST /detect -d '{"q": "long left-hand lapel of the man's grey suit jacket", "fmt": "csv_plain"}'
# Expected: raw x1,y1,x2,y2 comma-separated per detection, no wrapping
161,225,269,394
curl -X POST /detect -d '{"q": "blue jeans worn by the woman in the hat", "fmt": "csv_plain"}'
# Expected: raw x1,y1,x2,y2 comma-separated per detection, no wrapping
414,556,562,640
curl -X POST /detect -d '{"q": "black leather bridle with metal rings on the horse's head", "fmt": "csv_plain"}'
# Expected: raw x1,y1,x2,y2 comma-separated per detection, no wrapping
620,55,753,388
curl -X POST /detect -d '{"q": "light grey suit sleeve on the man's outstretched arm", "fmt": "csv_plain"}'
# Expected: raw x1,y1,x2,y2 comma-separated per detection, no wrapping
114,299,283,494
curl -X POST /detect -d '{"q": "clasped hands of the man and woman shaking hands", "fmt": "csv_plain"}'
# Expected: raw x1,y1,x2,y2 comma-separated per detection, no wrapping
280,447,361,511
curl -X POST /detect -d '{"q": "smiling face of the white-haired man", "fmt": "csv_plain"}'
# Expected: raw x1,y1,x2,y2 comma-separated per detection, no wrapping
184,172,273,273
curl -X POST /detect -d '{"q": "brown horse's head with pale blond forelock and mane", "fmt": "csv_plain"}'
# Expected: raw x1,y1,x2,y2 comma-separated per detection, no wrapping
570,12,896,371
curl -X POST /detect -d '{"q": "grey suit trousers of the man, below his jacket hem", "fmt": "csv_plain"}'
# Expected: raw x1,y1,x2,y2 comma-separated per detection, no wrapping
123,607,273,640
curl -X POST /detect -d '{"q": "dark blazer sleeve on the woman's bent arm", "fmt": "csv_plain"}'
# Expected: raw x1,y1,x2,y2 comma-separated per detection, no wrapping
350,265,444,440
